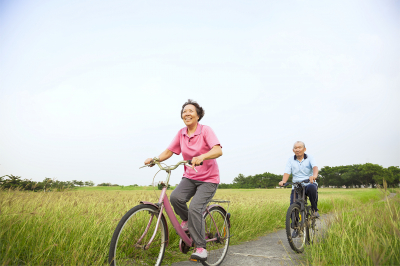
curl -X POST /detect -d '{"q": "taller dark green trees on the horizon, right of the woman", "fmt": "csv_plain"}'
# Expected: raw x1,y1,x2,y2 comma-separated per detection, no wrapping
218,163,400,189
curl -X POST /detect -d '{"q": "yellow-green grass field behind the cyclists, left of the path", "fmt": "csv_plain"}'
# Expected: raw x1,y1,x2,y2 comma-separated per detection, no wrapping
0,187,394,265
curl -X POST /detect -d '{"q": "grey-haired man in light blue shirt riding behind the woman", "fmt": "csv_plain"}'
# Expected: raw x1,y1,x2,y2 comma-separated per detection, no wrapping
279,141,319,218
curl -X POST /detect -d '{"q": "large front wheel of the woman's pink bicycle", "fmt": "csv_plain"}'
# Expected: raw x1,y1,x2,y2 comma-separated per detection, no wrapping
108,205,167,266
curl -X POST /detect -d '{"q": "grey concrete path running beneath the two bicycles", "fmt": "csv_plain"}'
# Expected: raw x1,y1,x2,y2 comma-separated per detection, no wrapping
172,215,329,266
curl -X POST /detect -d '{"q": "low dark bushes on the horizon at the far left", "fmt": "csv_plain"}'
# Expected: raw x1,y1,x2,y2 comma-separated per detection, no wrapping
0,175,94,191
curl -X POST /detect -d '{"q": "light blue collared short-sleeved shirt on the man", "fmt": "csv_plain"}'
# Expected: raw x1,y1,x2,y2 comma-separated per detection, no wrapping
285,154,318,186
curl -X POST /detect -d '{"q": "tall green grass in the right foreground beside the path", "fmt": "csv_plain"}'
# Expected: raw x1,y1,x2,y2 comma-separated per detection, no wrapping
306,191,400,265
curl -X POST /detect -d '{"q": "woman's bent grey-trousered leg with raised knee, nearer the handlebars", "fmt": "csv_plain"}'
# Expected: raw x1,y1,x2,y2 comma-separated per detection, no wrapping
169,177,196,221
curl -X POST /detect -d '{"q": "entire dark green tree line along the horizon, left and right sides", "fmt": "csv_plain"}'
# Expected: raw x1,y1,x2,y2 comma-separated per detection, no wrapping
0,163,400,191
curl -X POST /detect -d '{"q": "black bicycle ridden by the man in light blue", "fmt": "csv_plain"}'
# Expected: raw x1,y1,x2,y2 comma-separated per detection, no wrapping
283,179,317,253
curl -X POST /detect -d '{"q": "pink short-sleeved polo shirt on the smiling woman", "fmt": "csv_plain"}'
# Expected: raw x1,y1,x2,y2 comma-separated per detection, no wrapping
168,124,222,184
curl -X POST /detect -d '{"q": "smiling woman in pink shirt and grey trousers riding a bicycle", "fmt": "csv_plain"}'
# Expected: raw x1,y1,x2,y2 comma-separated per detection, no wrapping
144,100,222,260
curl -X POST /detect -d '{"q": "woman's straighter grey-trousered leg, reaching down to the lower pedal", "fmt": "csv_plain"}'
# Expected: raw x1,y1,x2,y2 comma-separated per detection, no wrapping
188,181,218,248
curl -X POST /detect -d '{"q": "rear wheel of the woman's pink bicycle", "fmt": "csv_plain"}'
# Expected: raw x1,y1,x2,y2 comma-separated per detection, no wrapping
201,206,230,266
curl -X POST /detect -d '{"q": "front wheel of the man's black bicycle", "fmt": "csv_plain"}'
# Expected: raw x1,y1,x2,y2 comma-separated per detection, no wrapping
286,203,307,253
